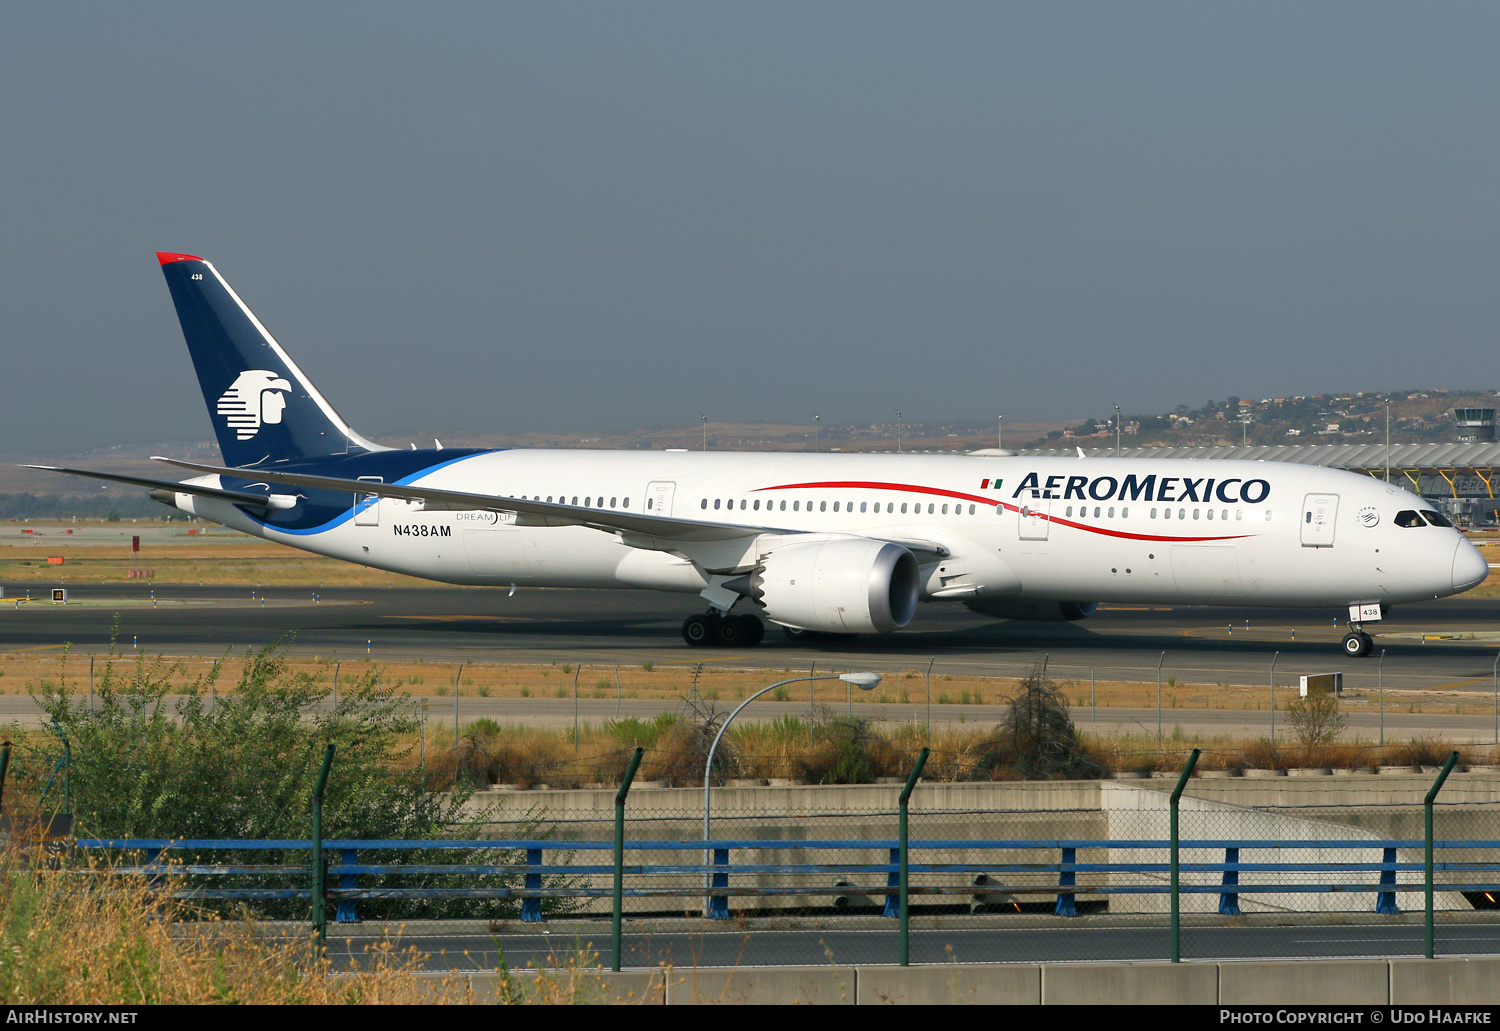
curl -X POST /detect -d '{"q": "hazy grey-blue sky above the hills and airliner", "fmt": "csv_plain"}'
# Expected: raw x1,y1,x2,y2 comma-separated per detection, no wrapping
0,2,1500,450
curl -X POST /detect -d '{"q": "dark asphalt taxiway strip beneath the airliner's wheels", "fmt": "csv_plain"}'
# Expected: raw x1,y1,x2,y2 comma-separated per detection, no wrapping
0,584,1500,695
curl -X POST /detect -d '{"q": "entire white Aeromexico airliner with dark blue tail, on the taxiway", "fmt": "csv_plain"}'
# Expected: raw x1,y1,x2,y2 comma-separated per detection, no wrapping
29,254,1490,656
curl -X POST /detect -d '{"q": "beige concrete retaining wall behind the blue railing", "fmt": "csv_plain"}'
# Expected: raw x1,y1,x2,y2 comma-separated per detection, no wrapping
471,773,1500,914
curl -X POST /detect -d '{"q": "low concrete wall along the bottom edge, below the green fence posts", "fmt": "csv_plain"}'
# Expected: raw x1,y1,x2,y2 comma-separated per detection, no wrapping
447,957,1500,1005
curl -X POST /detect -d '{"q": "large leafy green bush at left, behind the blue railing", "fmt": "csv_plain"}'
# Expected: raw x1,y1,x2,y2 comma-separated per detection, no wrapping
17,647,567,918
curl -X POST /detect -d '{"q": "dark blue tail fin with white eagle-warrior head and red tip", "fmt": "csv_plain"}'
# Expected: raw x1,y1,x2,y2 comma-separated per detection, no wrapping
156,251,389,465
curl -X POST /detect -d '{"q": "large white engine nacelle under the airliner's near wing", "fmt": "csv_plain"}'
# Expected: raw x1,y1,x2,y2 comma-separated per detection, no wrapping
750,537,921,633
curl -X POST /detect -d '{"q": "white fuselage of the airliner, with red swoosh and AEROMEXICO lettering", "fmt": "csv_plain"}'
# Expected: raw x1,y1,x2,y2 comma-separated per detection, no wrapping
172,450,1490,630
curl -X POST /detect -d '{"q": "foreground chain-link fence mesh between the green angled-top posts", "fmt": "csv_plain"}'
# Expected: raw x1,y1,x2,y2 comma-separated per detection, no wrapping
26,759,1500,966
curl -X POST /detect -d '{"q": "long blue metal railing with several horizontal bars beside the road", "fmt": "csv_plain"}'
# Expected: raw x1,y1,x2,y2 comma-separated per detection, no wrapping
77,839,1500,923
